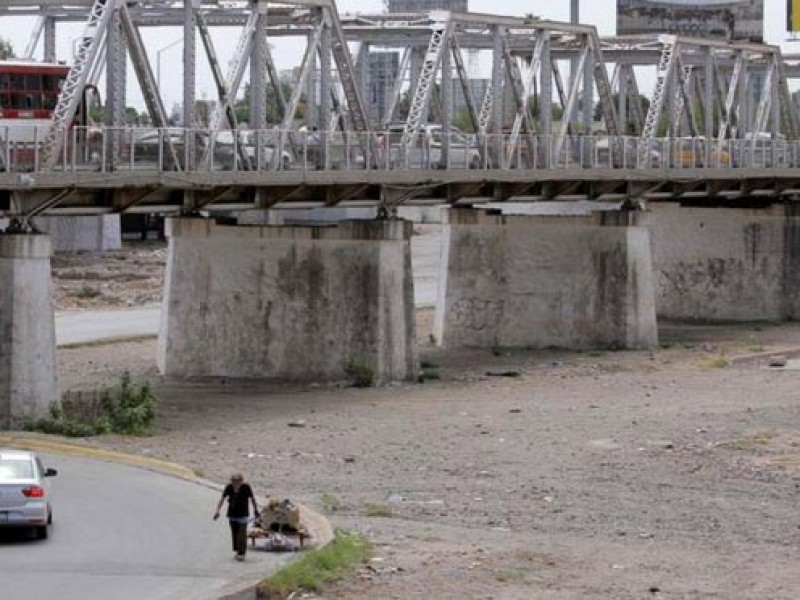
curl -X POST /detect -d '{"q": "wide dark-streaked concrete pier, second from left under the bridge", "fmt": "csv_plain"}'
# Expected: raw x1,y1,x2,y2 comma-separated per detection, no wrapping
158,218,418,383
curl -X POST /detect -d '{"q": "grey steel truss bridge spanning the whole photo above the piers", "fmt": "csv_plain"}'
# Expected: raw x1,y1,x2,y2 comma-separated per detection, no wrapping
0,0,800,220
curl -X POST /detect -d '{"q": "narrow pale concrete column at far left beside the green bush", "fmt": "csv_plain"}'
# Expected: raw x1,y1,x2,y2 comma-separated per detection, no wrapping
0,234,58,428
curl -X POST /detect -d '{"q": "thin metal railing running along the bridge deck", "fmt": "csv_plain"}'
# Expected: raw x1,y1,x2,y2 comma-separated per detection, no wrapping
0,125,800,173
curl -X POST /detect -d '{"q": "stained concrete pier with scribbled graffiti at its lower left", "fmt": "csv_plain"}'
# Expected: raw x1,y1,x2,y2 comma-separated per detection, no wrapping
435,209,658,350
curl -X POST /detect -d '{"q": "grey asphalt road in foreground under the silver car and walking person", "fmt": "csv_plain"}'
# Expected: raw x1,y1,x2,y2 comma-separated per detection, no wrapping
0,456,290,600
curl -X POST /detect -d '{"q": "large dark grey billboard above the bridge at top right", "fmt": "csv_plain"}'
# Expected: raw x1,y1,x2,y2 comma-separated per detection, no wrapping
617,0,764,42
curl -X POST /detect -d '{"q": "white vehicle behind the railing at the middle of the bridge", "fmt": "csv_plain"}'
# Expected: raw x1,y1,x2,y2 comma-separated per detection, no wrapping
383,123,481,169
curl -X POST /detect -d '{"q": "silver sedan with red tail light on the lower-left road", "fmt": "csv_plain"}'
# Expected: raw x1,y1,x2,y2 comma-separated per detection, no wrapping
0,448,57,540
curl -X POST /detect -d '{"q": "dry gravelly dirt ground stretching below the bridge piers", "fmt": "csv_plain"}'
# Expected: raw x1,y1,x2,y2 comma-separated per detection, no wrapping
58,311,800,600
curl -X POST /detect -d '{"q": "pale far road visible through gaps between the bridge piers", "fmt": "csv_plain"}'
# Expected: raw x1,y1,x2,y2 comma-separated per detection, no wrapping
56,226,441,346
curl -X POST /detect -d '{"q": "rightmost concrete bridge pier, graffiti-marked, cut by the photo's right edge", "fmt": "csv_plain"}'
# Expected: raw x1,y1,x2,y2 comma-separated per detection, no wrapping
648,203,800,322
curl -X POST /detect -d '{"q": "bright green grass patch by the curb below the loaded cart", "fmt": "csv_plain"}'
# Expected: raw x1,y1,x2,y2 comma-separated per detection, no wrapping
256,530,372,600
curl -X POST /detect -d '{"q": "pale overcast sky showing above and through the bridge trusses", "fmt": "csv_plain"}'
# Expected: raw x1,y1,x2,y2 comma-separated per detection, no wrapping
0,0,800,110
